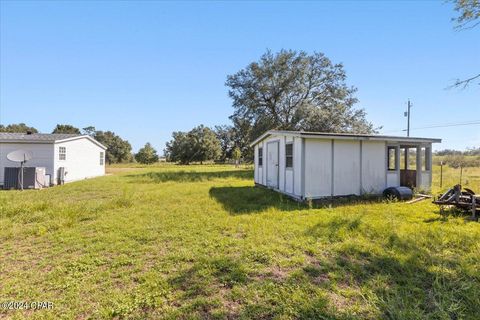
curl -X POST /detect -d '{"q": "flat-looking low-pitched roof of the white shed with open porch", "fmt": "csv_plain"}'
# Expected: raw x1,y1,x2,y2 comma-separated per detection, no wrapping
250,130,442,146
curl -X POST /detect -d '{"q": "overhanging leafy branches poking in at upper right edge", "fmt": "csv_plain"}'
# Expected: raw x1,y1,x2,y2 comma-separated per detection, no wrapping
452,0,480,89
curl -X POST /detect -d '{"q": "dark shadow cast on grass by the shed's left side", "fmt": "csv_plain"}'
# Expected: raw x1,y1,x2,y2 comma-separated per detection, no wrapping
209,186,308,214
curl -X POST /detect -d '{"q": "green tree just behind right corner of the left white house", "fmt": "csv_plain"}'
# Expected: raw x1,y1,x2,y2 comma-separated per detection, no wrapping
94,131,132,164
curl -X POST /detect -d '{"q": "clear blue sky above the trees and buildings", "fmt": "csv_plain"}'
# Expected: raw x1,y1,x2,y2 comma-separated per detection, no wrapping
0,1,480,151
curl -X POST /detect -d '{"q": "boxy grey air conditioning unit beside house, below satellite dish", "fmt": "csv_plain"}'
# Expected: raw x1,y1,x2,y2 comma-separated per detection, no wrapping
3,167,50,189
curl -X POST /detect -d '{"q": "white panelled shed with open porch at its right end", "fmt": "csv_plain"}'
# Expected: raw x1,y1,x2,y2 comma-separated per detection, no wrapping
251,130,441,199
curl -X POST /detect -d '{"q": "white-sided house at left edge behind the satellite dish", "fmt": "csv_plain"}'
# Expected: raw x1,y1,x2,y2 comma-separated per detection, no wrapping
0,132,107,185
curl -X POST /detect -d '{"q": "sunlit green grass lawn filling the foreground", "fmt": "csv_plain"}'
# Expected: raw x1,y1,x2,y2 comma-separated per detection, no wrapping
0,165,480,319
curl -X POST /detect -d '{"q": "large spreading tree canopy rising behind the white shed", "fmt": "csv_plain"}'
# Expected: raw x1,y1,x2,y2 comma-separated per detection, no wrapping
226,50,374,141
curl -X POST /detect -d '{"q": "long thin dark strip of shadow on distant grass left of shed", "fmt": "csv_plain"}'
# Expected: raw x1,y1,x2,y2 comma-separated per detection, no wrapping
126,170,253,183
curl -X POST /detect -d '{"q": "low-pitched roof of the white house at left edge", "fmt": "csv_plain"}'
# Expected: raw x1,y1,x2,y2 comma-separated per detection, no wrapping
0,132,107,149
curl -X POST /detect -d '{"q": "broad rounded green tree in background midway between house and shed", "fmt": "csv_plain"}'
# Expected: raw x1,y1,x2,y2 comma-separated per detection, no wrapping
165,125,222,164
